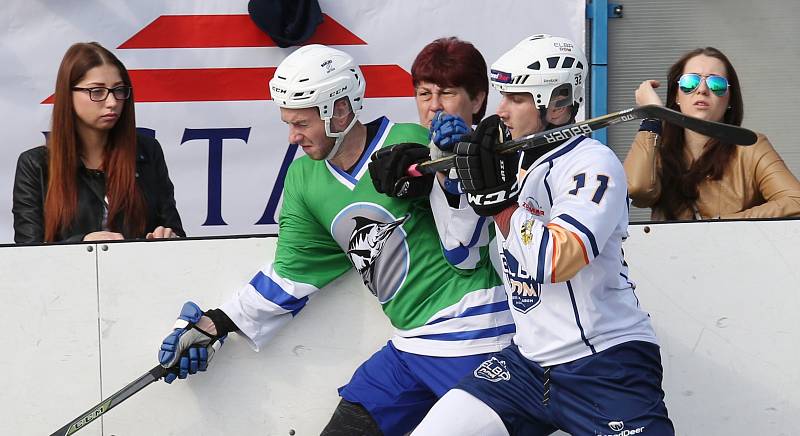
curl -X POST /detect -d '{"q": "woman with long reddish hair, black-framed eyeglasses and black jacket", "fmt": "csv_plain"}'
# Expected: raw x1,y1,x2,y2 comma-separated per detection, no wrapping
12,42,185,243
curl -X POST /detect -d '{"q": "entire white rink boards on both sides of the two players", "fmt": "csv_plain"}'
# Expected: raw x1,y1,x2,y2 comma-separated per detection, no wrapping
0,221,800,436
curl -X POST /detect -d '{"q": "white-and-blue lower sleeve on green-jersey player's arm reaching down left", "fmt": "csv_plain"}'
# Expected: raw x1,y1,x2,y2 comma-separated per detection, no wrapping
220,262,319,351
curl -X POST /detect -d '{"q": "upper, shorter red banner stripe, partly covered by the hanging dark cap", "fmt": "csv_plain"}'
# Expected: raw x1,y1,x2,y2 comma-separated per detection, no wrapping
117,14,366,49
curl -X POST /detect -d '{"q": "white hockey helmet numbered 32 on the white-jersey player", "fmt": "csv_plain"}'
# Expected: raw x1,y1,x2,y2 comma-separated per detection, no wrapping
489,34,588,111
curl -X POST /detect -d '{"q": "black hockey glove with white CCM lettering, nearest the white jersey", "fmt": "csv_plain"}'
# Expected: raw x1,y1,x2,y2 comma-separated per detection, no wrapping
454,115,518,216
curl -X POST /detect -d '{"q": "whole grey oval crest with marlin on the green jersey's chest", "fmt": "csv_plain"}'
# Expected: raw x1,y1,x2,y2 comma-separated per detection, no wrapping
331,203,410,303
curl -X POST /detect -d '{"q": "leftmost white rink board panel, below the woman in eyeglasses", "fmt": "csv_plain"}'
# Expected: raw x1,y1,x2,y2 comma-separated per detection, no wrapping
0,245,103,436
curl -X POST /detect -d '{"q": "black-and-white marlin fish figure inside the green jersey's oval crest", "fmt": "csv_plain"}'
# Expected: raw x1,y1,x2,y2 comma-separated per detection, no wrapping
347,215,408,296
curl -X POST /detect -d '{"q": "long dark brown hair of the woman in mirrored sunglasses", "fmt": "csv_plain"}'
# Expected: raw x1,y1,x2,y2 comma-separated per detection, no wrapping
653,47,744,220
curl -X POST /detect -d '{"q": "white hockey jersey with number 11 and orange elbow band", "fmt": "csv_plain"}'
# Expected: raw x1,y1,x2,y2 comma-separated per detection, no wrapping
497,136,657,366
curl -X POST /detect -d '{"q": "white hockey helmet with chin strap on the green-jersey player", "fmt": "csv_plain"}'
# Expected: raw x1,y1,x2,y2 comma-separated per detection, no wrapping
269,44,366,159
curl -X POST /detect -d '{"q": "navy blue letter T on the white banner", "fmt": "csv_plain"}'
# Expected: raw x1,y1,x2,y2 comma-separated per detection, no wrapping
181,127,250,226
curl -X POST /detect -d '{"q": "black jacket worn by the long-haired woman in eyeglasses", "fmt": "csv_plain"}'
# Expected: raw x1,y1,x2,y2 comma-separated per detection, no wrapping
11,134,186,243
